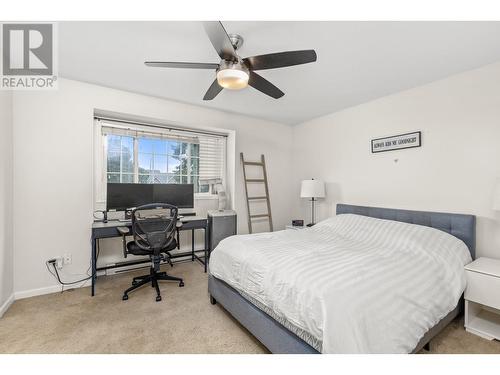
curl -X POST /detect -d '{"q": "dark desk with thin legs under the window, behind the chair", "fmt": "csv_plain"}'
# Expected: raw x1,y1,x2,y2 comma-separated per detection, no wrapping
91,216,210,296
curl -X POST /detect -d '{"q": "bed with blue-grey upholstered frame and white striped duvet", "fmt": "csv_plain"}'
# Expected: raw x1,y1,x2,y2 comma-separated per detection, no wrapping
208,204,475,354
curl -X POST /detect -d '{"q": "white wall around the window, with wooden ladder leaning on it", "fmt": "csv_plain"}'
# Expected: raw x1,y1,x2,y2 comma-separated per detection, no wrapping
13,79,292,297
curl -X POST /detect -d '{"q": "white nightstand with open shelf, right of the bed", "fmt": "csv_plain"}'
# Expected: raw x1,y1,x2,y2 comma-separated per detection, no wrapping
465,258,500,340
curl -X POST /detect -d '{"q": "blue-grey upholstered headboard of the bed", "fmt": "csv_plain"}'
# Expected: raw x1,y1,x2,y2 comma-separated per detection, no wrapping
337,204,476,259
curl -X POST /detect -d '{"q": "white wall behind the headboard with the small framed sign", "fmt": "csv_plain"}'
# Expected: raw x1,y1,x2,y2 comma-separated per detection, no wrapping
293,63,500,258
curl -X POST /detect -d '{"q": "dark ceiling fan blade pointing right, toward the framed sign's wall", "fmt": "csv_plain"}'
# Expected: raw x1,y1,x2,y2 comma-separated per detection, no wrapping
243,49,317,70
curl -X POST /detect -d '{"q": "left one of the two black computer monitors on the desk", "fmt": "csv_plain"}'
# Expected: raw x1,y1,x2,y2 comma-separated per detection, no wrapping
106,183,153,211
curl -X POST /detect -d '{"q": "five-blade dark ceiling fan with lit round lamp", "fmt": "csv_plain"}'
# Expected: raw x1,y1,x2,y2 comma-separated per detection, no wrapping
144,21,316,100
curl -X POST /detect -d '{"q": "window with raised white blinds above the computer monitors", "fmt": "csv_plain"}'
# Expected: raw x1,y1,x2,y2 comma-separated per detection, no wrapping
96,120,226,202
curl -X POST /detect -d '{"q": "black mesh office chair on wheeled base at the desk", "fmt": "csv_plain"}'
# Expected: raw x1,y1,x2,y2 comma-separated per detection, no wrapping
118,203,184,302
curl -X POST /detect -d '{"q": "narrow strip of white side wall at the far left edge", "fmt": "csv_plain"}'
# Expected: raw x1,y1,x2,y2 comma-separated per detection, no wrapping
0,91,14,317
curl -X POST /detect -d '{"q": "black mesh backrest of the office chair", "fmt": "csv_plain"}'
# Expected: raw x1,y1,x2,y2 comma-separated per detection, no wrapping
132,203,178,256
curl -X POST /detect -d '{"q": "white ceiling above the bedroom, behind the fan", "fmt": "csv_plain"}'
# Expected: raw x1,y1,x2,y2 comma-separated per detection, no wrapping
59,22,500,124
